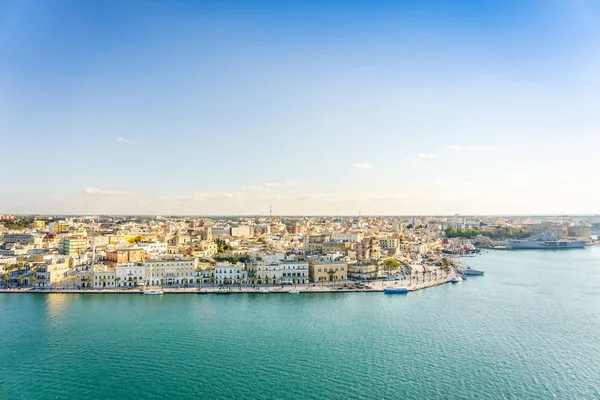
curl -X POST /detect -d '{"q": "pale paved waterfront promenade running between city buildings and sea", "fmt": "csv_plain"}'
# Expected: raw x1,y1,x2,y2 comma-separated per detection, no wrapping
0,272,456,294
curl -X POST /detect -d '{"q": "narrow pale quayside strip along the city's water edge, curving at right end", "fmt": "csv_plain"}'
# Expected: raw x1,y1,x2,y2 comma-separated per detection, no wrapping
0,274,456,295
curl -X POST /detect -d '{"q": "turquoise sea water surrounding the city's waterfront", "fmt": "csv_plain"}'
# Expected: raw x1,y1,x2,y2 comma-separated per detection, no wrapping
0,247,600,399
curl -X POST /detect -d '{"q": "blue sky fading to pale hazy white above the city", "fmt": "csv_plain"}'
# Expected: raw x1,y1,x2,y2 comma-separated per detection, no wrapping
0,0,600,215
